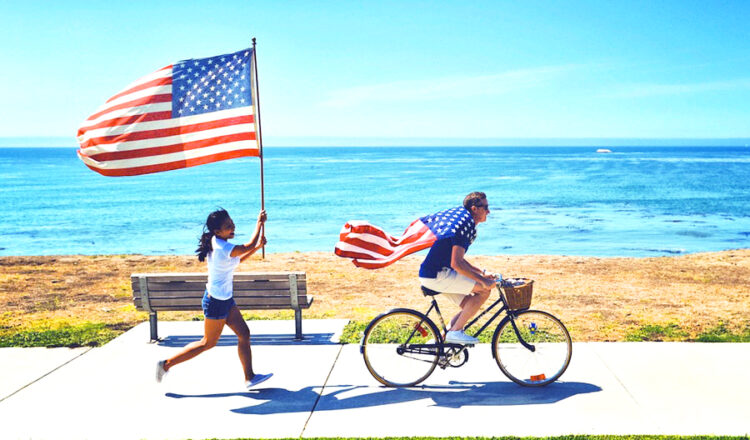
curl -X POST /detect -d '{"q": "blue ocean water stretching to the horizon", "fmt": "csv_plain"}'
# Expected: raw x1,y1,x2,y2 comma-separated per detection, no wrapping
0,147,750,256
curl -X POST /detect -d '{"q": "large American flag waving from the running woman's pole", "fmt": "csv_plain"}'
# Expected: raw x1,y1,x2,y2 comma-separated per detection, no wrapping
78,49,260,176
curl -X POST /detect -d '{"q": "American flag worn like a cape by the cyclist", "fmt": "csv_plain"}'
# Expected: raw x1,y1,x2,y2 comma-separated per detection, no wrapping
334,206,477,269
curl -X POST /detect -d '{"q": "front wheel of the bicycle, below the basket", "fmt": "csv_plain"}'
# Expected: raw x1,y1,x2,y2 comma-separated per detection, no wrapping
492,310,573,387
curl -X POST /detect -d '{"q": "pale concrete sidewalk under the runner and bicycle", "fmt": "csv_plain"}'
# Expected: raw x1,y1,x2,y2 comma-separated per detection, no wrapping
0,320,750,439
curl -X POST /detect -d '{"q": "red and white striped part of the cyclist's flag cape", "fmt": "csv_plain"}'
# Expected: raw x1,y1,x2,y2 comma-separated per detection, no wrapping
335,219,437,269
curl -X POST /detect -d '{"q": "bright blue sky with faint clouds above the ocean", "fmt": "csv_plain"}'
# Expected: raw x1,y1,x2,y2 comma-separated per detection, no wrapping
0,0,750,145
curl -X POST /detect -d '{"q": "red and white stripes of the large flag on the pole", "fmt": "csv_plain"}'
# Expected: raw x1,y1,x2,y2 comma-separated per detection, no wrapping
78,52,260,176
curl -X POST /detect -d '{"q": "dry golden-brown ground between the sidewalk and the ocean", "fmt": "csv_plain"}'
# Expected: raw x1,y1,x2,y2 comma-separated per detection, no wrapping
0,249,750,341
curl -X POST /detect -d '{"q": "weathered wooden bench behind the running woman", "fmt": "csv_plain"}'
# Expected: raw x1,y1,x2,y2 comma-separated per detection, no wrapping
130,272,313,341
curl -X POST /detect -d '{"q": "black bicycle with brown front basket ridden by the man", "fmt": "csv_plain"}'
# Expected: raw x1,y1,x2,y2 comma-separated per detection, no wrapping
360,279,573,387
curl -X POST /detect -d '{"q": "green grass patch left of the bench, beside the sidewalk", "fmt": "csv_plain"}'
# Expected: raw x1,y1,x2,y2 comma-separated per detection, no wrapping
0,322,125,347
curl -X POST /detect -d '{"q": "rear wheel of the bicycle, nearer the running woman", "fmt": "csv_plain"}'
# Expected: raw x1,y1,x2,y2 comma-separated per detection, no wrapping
362,309,440,387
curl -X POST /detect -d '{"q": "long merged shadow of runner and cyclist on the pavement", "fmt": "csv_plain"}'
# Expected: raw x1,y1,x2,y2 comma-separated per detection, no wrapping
166,381,602,415
